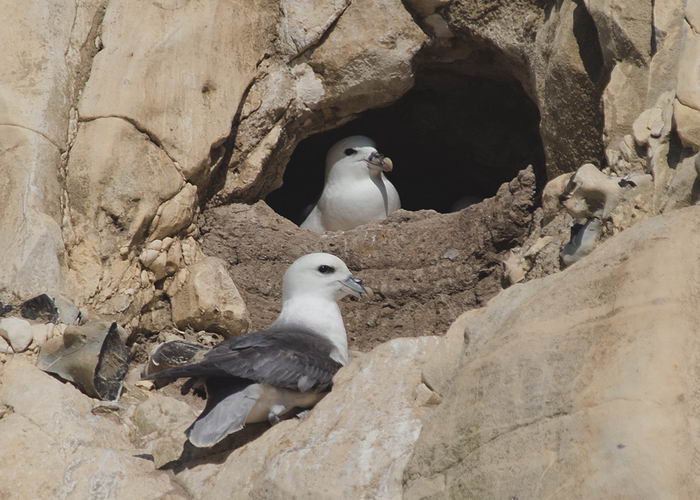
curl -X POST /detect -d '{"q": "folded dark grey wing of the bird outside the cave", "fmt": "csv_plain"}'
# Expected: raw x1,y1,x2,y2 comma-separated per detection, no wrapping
149,327,342,392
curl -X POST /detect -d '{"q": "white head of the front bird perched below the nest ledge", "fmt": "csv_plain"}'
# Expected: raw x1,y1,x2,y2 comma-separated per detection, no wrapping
282,253,367,301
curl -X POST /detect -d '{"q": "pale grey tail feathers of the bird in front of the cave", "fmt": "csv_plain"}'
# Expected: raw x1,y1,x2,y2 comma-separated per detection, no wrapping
185,378,260,448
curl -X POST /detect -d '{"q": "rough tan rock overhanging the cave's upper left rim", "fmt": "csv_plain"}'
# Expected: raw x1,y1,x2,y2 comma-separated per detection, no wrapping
217,0,427,200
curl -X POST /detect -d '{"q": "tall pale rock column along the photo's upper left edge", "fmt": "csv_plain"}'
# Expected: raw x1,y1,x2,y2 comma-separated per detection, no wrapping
0,0,104,299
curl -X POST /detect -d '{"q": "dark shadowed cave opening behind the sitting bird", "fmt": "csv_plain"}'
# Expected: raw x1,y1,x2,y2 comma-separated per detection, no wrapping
266,72,545,224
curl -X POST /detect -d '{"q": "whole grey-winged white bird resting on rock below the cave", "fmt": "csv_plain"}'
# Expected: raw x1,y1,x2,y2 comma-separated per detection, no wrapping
146,253,366,447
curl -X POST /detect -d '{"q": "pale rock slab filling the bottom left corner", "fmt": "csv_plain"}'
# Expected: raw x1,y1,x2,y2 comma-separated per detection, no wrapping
0,358,187,500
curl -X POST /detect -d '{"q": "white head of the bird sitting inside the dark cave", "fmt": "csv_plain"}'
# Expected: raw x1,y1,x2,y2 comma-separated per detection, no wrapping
326,135,394,180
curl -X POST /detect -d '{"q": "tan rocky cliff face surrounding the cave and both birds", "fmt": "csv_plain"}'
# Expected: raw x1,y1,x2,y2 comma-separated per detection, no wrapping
0,0,700,499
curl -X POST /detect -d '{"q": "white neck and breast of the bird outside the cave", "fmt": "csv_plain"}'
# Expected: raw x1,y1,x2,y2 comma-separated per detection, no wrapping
274,295,348,365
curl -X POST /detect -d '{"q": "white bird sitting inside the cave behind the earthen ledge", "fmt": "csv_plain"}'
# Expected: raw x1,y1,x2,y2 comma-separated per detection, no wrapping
301,135,401,233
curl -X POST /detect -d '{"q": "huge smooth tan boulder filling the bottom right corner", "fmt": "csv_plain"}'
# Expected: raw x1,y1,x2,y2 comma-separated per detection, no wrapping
405,208,700,499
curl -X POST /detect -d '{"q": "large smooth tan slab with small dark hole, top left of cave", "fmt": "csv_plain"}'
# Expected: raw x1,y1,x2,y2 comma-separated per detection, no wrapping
79,1,278,184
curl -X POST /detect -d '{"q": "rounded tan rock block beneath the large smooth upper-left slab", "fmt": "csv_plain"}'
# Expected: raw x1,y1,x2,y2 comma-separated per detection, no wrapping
66,118,184,314
